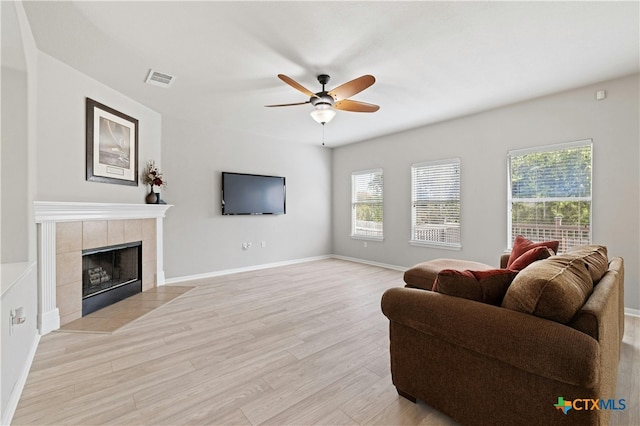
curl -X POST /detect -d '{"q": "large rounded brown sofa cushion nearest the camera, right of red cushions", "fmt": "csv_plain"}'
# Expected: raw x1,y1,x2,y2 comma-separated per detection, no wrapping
502,254,593,324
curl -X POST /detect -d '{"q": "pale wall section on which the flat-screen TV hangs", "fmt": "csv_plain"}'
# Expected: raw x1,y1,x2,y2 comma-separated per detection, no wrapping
162,118,331,280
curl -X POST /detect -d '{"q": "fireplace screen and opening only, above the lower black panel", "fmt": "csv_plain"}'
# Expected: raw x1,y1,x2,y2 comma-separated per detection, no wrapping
82,241,142,299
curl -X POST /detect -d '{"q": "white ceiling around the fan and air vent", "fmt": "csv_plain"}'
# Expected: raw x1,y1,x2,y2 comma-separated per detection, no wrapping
24,1,640,146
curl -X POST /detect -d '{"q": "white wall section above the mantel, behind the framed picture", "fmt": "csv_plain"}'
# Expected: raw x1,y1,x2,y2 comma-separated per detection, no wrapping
36,52,162,203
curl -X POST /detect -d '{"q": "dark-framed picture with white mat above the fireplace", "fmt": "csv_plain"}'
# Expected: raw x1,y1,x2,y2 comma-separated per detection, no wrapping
86,98,138,186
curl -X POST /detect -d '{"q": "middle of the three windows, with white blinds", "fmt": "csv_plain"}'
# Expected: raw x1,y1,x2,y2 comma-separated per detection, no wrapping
411,158,461,248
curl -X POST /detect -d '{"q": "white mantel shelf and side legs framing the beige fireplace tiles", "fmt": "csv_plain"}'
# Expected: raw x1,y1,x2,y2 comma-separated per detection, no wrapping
33,201,171,334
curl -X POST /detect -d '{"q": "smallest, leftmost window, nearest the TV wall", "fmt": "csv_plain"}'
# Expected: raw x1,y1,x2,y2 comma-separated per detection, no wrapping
351,169,383,240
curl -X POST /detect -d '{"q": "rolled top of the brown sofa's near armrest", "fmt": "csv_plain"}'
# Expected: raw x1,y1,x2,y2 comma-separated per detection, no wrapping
382,288,600,388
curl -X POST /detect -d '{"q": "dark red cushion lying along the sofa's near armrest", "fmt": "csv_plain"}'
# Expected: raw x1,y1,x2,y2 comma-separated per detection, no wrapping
433,269,517,306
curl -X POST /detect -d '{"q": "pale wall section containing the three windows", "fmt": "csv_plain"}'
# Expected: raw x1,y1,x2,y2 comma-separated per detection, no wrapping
333,75,640,309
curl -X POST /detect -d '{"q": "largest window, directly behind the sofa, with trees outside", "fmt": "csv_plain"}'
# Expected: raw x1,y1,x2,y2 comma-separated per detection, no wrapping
507,139,592,252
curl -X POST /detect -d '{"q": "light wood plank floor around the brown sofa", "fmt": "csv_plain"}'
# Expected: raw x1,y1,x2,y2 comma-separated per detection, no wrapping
12,259,640,425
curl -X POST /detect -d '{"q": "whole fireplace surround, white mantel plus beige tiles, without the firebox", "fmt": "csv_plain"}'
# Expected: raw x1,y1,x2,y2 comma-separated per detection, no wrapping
34,201,171,334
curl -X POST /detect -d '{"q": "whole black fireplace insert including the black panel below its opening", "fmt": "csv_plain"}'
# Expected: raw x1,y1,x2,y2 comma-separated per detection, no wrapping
82,241,142,316
